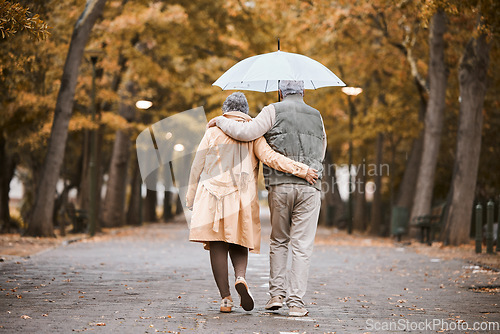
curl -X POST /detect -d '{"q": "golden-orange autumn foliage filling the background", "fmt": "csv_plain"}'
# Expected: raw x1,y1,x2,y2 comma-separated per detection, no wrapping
0,0,500,243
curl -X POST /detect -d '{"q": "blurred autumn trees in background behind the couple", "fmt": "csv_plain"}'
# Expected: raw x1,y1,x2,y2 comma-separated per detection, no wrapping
0,0,500,244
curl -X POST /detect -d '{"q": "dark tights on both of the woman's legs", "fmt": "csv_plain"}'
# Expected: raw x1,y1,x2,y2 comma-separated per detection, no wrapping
210,241,248,298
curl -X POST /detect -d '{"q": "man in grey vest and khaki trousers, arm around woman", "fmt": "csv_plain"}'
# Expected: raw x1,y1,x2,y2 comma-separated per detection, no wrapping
209,80,326,317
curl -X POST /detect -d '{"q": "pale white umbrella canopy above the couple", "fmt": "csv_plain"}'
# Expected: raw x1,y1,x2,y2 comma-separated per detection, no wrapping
213,51,345,92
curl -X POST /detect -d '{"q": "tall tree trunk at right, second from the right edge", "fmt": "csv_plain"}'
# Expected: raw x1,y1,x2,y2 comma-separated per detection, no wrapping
411,9,447,224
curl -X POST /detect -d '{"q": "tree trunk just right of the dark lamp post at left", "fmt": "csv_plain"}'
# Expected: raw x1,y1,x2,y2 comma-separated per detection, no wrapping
101,81,135,227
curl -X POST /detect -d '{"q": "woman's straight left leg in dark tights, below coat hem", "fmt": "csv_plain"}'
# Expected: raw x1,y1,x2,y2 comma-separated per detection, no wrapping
210,241,231,298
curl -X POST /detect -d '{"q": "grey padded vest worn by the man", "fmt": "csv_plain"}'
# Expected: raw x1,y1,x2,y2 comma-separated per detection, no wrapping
263,95,324,189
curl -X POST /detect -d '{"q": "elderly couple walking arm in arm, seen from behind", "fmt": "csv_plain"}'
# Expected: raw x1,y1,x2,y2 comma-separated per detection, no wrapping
186,80,326,317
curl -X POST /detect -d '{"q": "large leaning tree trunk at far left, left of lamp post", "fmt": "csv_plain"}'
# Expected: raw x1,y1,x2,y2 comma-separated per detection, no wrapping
26,0,106,236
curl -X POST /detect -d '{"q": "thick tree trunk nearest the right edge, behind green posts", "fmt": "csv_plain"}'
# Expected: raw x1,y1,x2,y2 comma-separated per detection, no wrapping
442,28,490,245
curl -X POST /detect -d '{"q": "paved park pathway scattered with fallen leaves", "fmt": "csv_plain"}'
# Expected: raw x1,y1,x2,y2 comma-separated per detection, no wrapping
0,210,500,334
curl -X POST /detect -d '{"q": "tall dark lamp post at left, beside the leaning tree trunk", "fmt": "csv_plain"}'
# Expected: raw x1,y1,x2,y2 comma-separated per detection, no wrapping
85,50,103,236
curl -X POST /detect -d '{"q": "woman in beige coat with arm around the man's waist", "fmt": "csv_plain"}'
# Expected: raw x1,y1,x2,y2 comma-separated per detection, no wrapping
186,92,318,312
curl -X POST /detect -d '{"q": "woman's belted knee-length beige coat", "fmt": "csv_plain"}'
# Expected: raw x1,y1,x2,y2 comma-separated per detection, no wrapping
186,111,309,253
